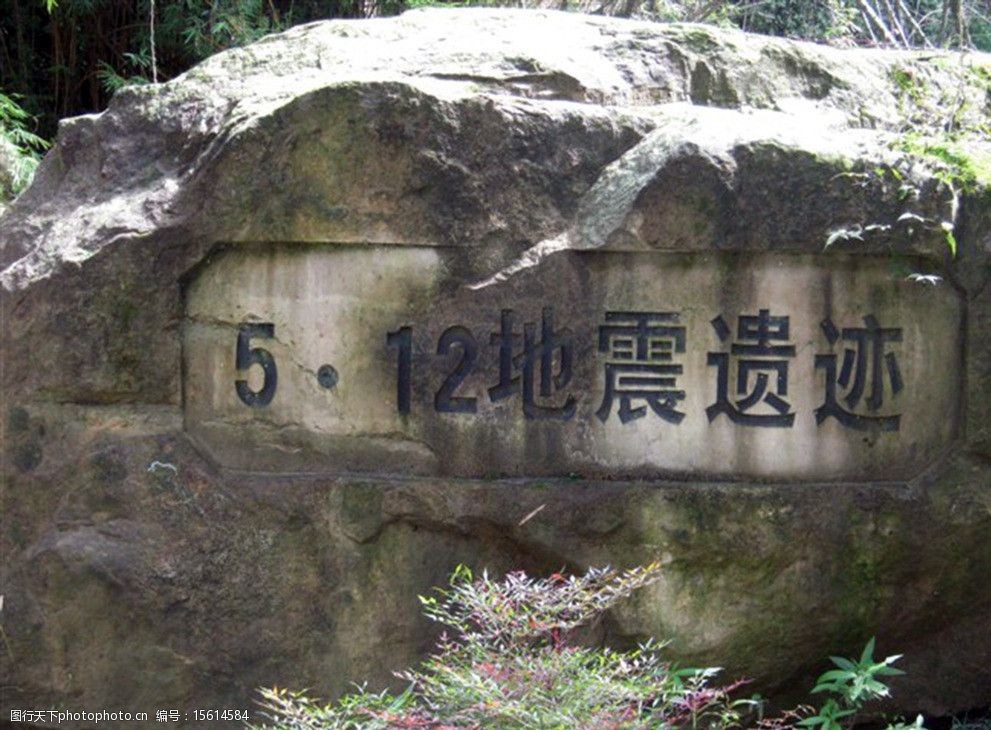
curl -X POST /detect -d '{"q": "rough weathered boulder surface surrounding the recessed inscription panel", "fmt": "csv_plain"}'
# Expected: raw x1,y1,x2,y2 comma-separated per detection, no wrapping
0,10,991,713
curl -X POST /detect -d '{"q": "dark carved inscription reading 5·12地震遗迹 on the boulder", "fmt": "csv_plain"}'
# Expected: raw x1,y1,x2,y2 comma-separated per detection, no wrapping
234,307,902,431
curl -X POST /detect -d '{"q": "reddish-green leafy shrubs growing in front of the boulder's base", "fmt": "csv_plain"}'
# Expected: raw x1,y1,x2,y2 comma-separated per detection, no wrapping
257,565,922,730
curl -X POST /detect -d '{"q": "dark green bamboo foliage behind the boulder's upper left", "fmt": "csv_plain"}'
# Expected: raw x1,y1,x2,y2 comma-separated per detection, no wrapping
0,0,334,136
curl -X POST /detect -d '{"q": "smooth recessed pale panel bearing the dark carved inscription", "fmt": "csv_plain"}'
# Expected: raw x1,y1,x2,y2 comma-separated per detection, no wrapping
184,244,962,481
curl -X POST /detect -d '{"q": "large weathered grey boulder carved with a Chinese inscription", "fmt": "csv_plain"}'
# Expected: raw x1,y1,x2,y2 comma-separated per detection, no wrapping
0,10,991,717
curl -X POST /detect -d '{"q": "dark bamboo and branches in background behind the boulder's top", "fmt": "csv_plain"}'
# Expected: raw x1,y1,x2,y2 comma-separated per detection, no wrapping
0,0,991,139
